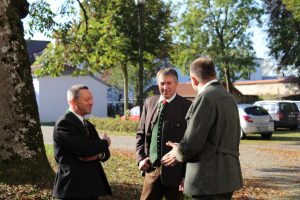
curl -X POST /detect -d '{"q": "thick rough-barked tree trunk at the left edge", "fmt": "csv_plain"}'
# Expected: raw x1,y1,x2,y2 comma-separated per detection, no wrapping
0,0,53,183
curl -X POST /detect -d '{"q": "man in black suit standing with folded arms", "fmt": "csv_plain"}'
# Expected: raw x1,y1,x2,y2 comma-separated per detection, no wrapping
53,85,112,200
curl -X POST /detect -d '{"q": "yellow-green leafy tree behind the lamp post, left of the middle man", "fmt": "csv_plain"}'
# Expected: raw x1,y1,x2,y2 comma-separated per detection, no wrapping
32,0,171,110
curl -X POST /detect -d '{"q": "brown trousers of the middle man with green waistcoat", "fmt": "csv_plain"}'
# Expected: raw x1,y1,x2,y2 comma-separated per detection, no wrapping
141,168,183,200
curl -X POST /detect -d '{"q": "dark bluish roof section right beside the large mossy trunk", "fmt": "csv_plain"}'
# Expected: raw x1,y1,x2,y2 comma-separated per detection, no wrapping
26,40,50,64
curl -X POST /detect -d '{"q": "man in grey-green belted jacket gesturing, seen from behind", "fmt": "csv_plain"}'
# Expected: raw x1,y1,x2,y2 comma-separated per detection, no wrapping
162,56,243,200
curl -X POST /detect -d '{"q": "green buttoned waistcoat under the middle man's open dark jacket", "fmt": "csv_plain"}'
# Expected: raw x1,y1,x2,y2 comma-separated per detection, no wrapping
150,100,168,166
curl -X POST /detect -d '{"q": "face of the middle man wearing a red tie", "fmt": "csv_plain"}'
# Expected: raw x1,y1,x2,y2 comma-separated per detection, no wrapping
157,75,177,99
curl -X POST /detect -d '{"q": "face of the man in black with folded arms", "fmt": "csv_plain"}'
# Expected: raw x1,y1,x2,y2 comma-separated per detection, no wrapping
74,89,94,116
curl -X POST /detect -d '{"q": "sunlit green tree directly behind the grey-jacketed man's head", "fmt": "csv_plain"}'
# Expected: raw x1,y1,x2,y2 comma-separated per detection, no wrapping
173,0,262,91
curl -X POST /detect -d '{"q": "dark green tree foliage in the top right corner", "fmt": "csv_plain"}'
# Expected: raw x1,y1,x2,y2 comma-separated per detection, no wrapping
264,0,300,77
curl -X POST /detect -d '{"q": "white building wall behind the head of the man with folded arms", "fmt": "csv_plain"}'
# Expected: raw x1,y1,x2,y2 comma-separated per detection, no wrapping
38,76,107,122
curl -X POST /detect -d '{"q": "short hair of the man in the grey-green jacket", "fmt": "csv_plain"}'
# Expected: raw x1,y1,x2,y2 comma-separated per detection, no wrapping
190,56,216,81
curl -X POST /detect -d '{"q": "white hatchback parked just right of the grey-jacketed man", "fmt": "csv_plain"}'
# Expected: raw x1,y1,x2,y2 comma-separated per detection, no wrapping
238,104,274,139
